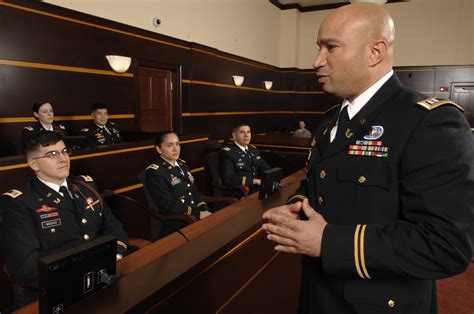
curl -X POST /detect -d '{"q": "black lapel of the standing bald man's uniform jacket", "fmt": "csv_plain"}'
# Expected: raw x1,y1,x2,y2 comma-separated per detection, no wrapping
318,74,402,162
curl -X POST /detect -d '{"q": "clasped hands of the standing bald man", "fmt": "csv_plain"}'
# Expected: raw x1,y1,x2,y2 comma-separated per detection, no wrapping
262,199,327,257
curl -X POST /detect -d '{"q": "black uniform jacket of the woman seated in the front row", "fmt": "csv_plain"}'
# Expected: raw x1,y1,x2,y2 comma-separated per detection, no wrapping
145,157,209,219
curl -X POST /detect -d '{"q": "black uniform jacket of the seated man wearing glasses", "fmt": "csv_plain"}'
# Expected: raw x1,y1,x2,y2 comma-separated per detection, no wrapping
0,176,128,283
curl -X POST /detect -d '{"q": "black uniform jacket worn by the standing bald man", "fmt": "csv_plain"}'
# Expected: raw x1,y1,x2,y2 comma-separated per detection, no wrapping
290,75,474,314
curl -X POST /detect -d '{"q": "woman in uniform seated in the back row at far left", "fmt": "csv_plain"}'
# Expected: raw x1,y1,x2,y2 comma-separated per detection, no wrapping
23,102,67,140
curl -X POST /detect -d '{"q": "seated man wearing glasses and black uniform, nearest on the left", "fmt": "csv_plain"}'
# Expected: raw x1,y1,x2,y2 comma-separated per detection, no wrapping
0,131,128,305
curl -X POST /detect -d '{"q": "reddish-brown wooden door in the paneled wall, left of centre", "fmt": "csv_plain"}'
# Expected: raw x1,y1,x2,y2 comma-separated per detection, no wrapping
137,67,174,132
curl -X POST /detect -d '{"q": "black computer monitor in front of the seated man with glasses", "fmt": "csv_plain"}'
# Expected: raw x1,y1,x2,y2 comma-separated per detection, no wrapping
39,235,117,313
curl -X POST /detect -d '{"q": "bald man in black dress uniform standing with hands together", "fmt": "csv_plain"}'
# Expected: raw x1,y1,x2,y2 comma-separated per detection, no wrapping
263,3,474,314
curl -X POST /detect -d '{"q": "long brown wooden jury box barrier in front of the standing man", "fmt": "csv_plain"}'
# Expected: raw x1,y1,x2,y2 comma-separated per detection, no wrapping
17,171,305,313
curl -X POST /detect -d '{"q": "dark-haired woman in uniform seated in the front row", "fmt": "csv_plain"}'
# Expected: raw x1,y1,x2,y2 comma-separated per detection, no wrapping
145,131,211,240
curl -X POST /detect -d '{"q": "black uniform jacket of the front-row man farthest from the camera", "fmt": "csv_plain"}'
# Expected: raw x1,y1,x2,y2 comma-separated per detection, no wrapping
219,144,271,188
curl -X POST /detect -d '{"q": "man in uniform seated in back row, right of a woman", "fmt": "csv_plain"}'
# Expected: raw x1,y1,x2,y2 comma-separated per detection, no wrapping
81,103,122,146
